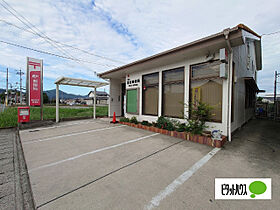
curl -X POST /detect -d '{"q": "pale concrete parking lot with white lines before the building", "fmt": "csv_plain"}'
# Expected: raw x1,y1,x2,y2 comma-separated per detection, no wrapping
20,120,279,209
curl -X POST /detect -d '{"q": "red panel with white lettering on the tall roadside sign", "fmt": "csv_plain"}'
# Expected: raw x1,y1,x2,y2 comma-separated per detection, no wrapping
30,71,41,106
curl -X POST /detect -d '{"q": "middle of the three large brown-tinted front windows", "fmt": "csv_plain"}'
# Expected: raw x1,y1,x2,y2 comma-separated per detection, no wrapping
162,67,184,118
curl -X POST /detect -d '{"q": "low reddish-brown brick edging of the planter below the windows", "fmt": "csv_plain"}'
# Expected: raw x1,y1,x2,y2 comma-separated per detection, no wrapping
120,122,227,148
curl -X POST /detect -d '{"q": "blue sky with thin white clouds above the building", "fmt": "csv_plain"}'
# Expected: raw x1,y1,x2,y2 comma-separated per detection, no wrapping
0,0,280,94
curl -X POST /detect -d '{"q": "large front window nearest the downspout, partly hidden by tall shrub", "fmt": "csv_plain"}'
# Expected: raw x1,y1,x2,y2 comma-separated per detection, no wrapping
190,61,223,122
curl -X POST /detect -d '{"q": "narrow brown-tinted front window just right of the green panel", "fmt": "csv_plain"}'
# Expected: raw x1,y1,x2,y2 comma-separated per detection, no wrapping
142,73,159,115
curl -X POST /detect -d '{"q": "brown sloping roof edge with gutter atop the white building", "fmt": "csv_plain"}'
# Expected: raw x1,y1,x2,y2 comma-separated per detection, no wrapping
98,24,261,78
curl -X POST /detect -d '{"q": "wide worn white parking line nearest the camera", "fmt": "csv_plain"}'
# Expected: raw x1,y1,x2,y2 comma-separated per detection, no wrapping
145,148,220,210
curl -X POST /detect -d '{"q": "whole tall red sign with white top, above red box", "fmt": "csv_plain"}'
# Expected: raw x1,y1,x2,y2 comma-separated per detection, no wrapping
27,58,43,106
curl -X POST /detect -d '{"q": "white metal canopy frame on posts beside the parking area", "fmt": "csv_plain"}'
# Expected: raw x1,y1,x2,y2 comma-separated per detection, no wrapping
54,77,109,122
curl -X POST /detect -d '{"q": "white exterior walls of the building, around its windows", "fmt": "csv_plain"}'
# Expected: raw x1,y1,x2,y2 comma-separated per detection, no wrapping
110,31,256,136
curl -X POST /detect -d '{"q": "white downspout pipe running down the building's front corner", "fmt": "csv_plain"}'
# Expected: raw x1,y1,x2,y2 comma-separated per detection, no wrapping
224,29,233,142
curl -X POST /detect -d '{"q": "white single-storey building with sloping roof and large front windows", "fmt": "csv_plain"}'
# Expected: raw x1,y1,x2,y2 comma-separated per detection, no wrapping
99,24,262,135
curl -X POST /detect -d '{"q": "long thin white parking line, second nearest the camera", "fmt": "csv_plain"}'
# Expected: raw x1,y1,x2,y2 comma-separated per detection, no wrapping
29,133,159,172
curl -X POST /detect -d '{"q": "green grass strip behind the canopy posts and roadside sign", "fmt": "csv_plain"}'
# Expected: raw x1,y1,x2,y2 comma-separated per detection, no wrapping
0,106,108,128
